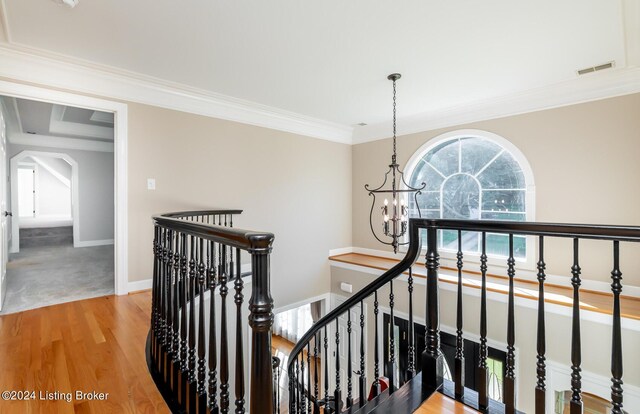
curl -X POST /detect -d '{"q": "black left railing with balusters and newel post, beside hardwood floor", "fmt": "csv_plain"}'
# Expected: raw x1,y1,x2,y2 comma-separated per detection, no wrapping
147,210,274,414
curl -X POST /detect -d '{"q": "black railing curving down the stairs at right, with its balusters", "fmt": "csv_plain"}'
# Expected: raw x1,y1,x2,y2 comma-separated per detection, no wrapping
287,219,640,414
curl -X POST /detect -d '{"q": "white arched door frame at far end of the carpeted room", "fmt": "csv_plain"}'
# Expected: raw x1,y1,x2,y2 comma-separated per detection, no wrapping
9,150,82,253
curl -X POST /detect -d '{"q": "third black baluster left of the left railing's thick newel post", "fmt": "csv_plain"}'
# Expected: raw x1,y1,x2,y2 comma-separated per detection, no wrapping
207,241,219,414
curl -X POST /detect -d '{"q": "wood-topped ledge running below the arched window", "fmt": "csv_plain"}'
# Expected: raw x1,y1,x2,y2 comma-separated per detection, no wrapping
329,253,640,320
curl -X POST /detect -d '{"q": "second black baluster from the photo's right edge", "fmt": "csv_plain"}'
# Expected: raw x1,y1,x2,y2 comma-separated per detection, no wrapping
569,238,582,414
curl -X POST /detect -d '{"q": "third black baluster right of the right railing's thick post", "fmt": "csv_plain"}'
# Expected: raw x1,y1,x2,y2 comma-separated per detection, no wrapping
504,234,516,414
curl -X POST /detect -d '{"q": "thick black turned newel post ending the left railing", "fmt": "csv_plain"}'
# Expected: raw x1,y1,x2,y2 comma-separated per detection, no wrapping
249,234,273,414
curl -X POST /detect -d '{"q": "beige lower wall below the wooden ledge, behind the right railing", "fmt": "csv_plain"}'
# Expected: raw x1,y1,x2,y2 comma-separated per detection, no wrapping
331,267,640,413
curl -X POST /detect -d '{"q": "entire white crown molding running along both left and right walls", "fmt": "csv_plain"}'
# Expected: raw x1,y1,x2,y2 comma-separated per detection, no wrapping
0,43,640,144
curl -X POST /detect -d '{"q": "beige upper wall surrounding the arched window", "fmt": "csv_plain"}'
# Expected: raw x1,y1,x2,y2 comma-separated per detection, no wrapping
352,94,640,286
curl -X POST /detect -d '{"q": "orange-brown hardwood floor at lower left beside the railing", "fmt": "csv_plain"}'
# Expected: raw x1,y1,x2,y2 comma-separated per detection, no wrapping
0,291,169,414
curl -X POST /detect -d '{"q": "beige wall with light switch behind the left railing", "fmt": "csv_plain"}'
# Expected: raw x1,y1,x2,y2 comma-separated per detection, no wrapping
128,103,351,307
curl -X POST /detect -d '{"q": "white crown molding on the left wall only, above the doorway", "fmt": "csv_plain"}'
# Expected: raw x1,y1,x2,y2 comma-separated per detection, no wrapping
0,43,353,144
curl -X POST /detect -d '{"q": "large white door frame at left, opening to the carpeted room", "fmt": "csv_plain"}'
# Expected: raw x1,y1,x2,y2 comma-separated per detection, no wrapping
0,80,129,295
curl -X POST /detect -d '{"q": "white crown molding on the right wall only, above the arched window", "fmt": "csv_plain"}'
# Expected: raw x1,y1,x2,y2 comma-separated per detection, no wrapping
352,67,640,144
